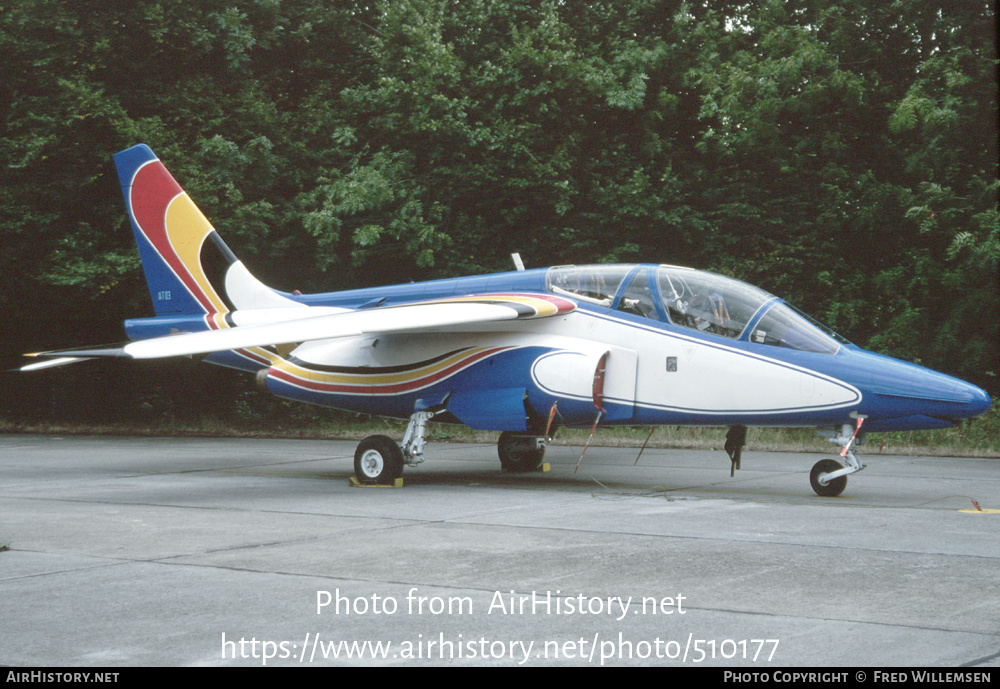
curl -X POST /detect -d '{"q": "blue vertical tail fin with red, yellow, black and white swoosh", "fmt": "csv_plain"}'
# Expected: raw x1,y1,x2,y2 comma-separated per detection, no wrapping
115,144,299,329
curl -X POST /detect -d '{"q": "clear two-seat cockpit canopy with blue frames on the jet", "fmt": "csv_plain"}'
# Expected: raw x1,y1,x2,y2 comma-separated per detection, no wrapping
546,265,849,354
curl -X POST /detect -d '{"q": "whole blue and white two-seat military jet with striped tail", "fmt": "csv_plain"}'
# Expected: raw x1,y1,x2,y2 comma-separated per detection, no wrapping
22,145,991,496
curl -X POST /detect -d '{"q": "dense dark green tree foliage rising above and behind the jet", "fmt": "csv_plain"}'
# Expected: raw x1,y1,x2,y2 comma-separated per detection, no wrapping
0,0,1000,422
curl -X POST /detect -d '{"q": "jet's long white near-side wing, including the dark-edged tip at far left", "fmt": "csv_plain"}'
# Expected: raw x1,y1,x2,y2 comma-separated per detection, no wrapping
21,294,576,370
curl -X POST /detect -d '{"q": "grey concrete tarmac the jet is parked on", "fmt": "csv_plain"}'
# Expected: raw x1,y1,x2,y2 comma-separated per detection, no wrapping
0,435,1000,668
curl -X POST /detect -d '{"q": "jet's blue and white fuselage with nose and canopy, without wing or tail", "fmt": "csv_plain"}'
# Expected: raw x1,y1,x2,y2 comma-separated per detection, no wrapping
240,265,990,431
